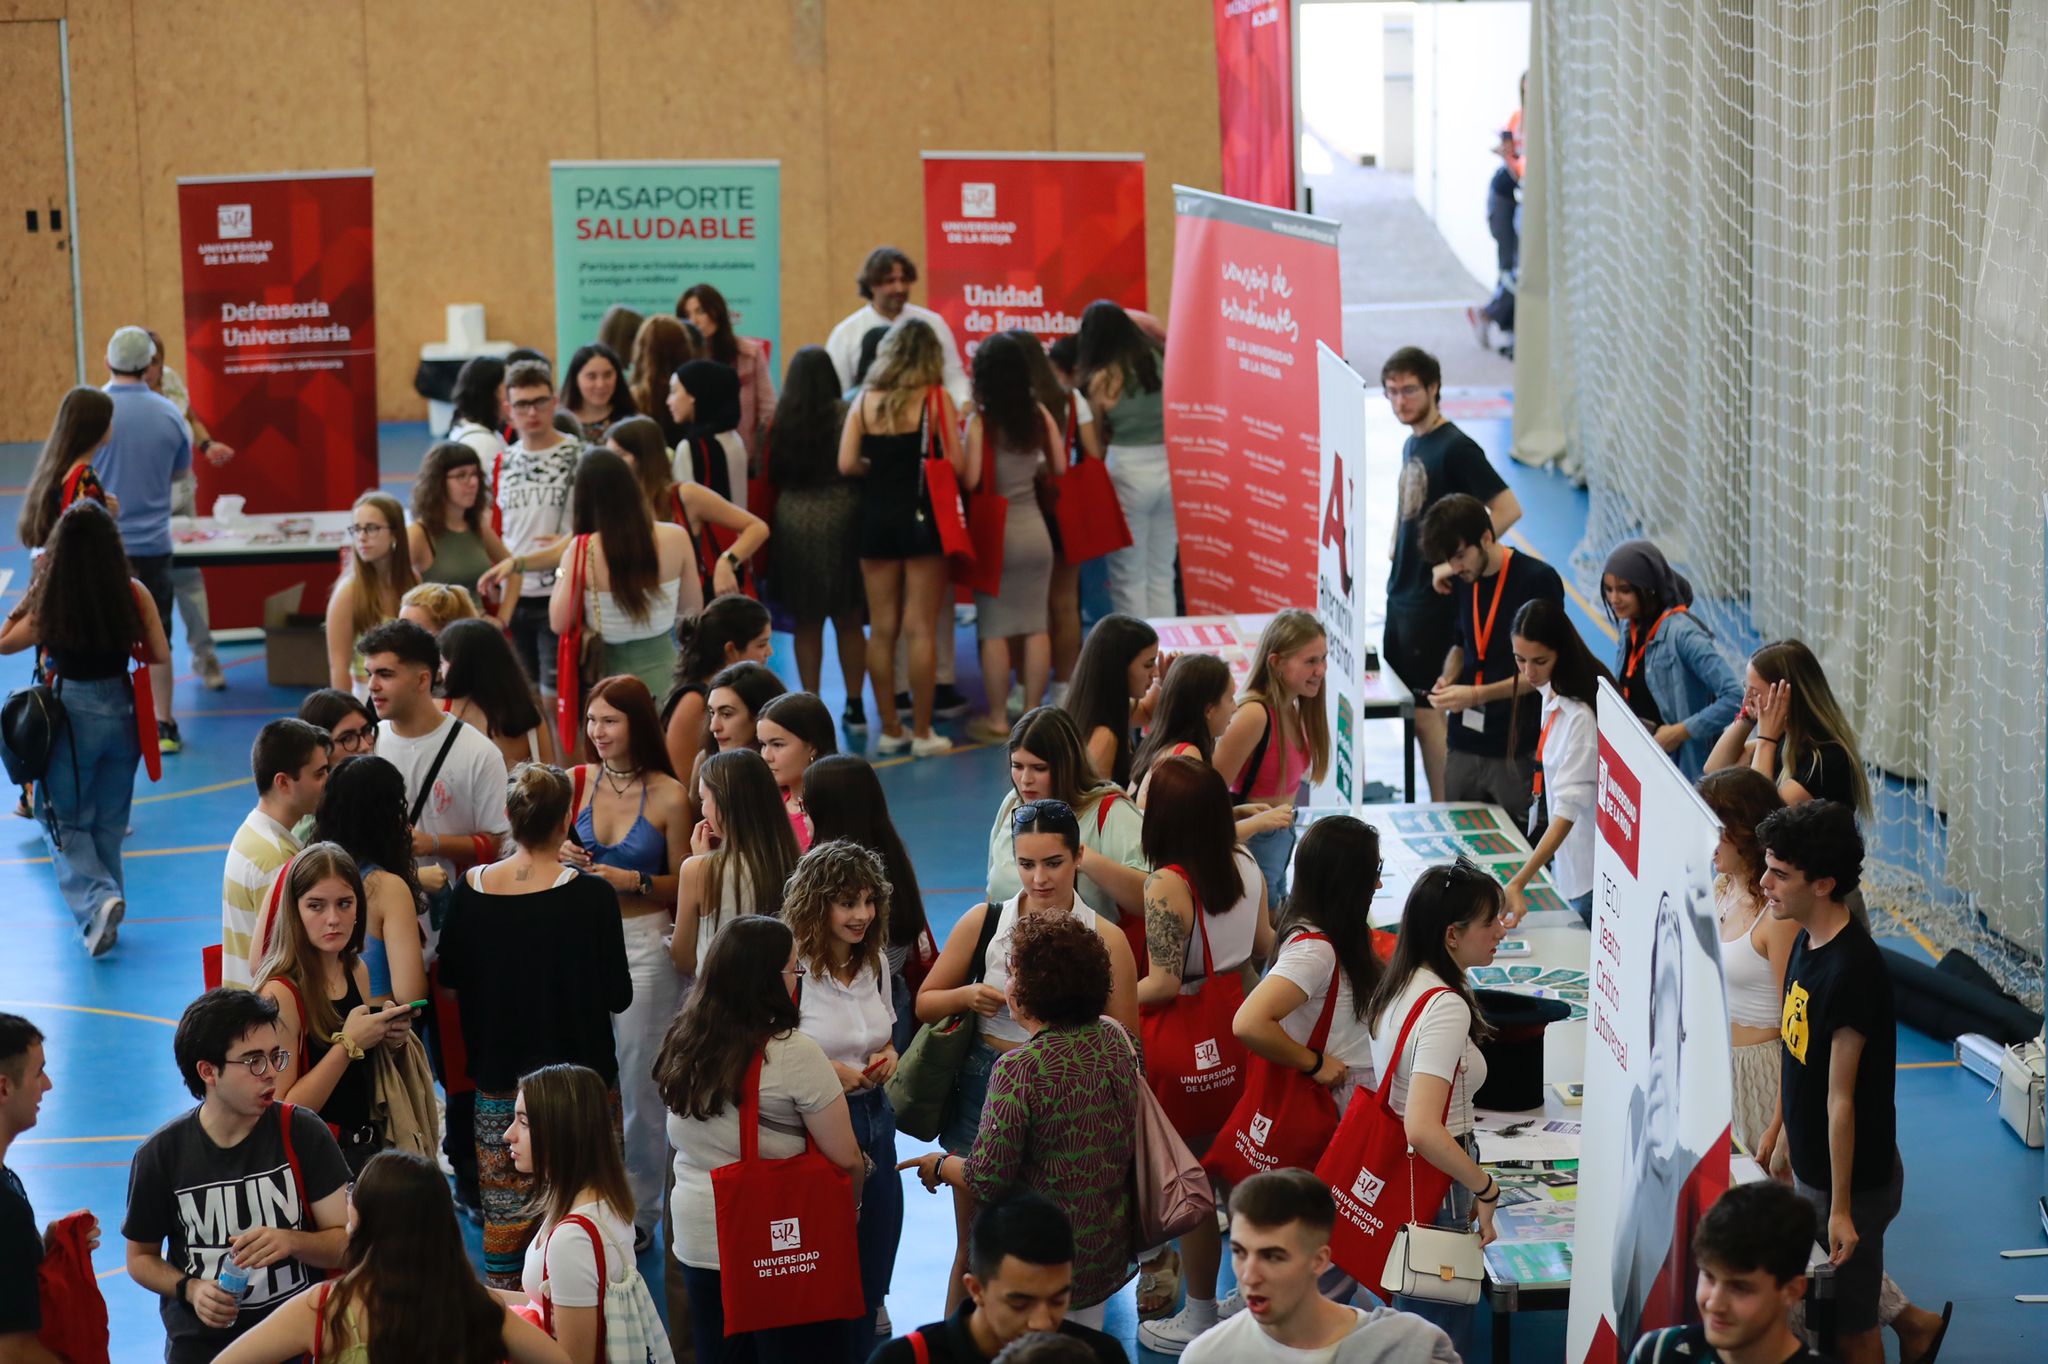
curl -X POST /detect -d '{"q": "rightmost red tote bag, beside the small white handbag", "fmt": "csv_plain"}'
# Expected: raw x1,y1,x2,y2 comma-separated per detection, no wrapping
1315,985,1450,1284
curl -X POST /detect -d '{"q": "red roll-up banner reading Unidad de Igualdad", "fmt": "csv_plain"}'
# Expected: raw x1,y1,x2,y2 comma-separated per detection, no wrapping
924,152,1145,360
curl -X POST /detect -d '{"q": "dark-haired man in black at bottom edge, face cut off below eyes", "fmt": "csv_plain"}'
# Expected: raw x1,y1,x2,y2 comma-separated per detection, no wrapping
868,1194,1130,1364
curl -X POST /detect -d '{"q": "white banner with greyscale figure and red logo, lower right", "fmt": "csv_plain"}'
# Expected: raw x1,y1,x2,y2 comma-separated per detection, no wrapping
1565,680,1735,1362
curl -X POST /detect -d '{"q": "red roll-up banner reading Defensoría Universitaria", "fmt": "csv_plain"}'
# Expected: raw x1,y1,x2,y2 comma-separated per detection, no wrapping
178,170,377,629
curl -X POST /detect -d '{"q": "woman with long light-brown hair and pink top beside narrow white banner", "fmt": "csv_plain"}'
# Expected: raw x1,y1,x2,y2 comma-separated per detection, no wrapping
1212,610,1329,903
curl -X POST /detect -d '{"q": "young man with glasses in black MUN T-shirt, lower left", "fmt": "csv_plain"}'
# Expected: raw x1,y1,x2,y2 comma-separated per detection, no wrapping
121,989,348,1364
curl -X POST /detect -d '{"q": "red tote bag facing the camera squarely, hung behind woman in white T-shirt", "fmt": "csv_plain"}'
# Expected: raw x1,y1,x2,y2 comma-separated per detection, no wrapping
711,1057,866,1337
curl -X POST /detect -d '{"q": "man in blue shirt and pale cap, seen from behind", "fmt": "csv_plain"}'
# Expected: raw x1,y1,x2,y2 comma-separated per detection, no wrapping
92,328,193,754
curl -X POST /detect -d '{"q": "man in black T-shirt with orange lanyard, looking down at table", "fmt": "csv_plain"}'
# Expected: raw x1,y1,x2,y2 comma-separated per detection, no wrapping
1421,494,1565,825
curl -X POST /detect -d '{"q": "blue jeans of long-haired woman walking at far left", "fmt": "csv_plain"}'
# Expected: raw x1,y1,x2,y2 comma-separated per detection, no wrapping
35,676,141,926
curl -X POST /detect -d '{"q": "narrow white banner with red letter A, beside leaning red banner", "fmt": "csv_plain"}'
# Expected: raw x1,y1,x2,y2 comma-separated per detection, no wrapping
1309,342,1366,805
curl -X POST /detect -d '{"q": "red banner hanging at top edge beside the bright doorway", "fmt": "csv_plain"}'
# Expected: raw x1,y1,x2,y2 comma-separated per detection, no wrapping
1217,0,1294,209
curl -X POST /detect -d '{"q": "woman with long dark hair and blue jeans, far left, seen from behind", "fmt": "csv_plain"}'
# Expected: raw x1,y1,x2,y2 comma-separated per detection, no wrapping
0,498,170,956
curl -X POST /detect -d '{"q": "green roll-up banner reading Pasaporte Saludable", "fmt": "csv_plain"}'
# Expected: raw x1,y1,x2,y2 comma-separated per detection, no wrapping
549,162,786,369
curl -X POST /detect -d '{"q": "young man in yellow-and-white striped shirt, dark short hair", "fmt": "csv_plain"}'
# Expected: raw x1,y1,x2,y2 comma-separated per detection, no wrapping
221,719,334,989
